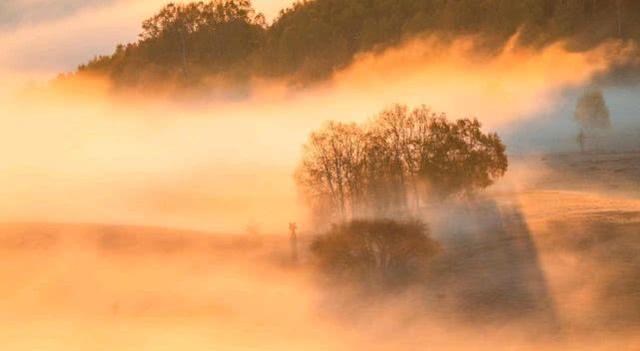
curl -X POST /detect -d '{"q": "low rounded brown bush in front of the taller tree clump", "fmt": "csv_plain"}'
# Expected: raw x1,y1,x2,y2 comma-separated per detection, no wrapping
311,220,440,287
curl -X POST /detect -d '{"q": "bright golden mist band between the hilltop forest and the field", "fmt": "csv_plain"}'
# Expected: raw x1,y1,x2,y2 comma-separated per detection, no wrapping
0,37,625,233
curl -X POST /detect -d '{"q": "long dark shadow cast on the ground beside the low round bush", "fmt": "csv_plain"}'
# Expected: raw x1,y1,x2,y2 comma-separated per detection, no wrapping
430,199,559,333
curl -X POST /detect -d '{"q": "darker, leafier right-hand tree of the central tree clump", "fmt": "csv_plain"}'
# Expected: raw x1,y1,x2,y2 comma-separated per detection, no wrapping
373,105,508,203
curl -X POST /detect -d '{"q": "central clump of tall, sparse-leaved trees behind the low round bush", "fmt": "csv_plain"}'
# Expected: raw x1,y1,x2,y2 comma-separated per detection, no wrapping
296,105,508,220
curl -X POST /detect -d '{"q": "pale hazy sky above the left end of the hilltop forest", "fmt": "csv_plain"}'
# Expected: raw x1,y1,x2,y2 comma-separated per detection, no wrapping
0,0,291,75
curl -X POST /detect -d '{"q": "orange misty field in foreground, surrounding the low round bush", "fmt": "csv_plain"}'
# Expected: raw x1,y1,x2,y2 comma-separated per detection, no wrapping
0,154,640,350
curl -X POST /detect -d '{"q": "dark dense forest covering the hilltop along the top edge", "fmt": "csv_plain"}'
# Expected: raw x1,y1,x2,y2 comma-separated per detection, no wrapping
77,0,640,88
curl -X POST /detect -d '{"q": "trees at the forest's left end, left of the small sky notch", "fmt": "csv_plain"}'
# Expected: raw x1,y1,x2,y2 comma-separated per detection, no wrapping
78,0,266,87
